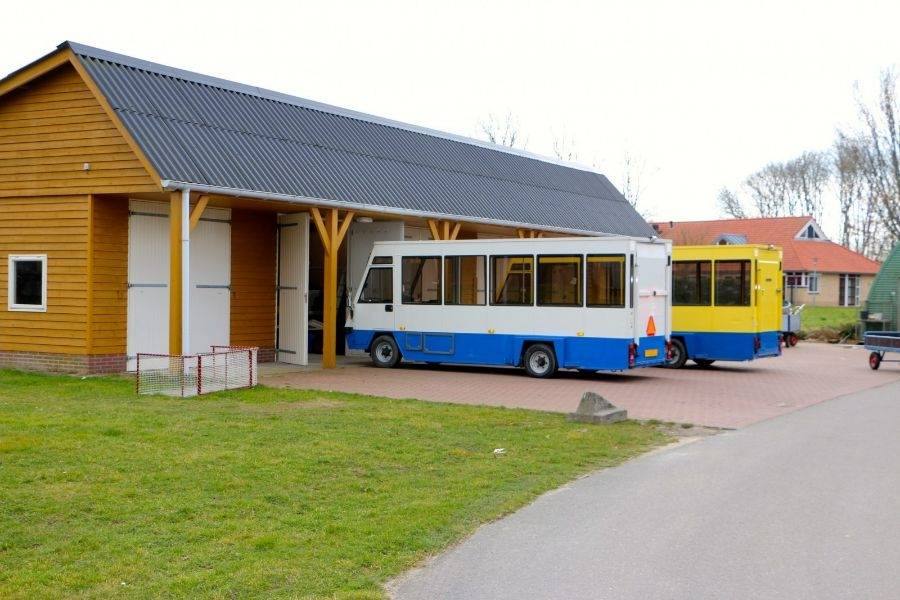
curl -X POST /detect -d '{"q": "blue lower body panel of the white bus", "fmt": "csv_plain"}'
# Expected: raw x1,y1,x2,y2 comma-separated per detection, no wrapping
346,330,666,371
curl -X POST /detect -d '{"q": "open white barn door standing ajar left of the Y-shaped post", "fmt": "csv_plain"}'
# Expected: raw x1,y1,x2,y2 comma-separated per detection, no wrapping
277,213,309,365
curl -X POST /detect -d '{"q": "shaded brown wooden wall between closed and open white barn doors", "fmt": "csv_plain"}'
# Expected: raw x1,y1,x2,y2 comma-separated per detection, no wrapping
231,210,276,348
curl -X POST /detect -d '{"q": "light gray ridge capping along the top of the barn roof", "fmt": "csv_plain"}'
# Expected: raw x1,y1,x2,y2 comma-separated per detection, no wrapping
57,40,605,177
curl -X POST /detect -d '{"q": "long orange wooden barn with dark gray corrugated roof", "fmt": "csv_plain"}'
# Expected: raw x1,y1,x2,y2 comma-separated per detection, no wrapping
0,42,654,373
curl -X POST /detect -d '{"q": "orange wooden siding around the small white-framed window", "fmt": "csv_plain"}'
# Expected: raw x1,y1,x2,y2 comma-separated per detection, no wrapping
0,196,90,354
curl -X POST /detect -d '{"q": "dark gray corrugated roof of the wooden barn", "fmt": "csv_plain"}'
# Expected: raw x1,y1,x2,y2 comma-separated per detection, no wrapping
61,42,654,236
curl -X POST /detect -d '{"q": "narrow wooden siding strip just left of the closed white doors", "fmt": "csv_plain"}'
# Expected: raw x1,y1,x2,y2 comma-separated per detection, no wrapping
88,197,128,354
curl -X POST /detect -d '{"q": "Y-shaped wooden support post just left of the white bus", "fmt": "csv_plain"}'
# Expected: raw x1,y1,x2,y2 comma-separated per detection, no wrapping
310,206,353,369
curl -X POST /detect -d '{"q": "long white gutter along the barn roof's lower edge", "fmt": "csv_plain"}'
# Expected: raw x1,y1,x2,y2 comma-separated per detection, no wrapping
160,179,636,237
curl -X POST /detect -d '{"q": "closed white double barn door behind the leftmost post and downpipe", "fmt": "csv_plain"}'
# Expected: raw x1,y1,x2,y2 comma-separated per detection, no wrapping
127,200,231,370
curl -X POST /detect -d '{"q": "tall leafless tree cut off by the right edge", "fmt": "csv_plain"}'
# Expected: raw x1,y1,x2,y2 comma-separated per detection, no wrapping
857,69,900,247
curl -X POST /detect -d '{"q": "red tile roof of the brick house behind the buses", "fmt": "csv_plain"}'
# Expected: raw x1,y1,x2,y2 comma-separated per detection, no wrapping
654,217,881,274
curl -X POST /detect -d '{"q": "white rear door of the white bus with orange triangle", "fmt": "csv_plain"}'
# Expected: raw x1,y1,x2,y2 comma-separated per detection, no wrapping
630,244,671,352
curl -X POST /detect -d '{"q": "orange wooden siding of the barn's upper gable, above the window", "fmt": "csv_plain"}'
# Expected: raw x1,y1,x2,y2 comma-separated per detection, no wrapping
0,64,160,198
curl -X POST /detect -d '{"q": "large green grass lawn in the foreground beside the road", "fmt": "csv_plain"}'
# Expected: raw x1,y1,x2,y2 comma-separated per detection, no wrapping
0,371,666,598
